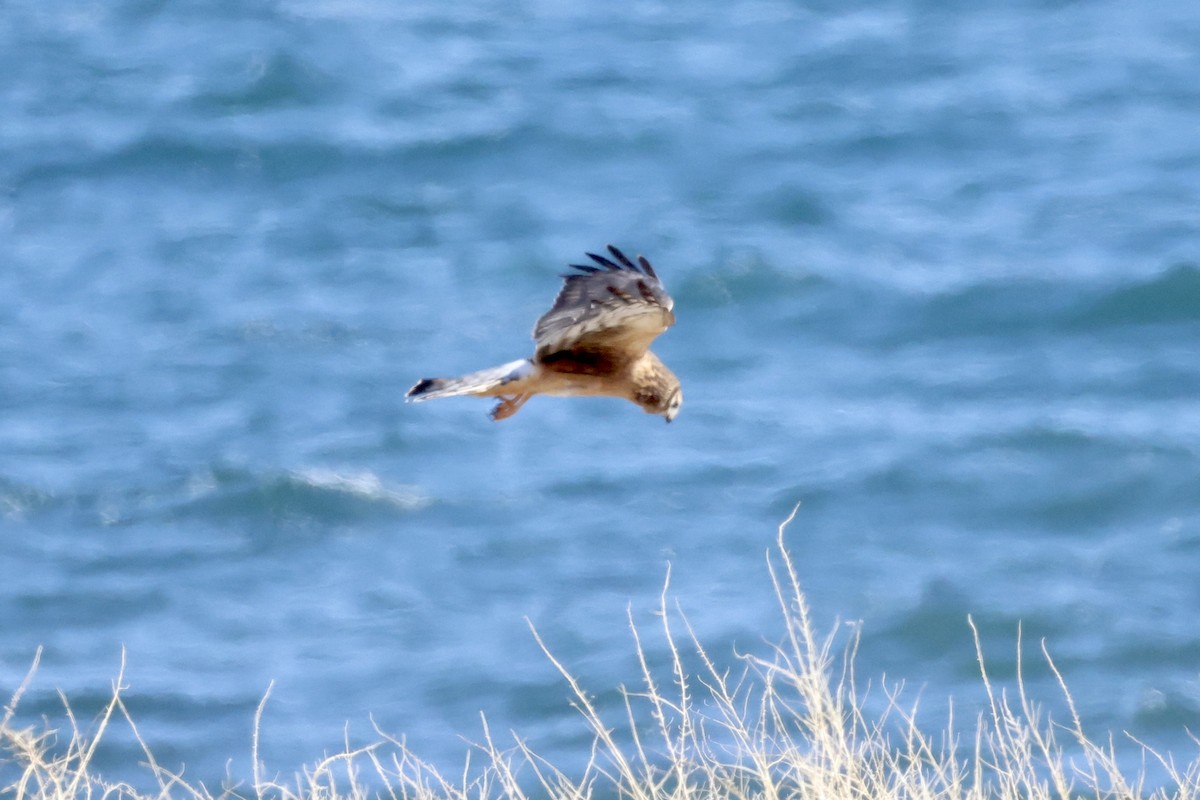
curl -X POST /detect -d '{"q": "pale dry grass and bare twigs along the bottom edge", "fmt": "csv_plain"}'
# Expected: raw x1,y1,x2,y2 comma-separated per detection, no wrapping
0,512,1200,800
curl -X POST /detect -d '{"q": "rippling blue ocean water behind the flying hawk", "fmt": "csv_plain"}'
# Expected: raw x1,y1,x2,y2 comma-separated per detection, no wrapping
0,0,1200,786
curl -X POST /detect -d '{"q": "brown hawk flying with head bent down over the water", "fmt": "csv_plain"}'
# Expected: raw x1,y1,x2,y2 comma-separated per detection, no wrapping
404,245,683,422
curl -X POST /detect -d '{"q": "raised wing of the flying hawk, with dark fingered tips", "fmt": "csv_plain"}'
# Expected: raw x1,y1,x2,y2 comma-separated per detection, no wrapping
533,245,674,363
